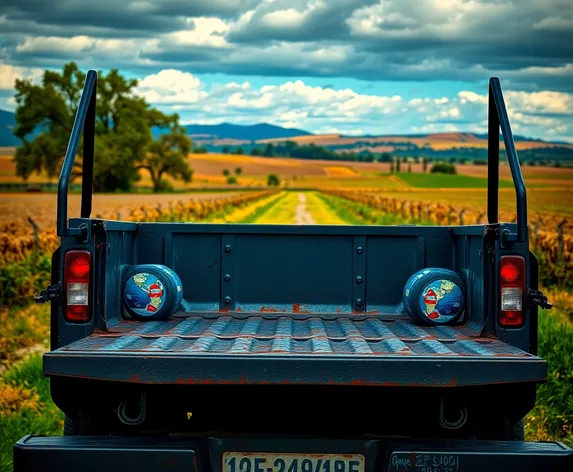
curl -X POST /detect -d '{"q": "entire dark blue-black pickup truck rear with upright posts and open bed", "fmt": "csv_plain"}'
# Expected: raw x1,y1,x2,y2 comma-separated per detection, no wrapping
14,71,573,472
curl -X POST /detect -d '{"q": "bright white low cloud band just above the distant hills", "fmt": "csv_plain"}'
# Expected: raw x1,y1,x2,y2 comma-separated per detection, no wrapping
124,69,573,138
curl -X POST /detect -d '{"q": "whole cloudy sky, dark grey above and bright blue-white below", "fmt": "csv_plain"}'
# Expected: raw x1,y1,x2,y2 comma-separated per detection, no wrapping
0,0,573,142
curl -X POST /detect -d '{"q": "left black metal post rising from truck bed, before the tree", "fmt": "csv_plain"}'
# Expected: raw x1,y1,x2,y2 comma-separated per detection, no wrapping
57,70,97,236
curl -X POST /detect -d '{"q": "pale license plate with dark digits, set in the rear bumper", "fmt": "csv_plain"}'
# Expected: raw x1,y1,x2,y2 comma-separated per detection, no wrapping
223,452,365,472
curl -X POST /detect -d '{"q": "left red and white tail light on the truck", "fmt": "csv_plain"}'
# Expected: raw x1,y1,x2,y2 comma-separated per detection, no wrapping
64,251,92,322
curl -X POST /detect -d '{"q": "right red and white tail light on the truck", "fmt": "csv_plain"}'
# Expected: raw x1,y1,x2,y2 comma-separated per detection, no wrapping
499,256,525,328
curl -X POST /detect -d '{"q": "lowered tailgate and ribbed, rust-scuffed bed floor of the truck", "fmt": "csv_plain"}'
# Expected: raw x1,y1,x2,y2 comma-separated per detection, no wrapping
44,314,547,386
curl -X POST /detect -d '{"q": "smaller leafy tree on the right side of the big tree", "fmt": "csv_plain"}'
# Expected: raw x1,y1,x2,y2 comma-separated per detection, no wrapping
137,119,193,192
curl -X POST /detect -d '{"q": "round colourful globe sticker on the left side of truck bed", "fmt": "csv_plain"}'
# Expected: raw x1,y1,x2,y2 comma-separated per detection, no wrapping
123,272,165,316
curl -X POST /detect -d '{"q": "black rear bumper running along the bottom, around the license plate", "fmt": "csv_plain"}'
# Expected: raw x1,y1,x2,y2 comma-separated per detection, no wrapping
14,436,573,472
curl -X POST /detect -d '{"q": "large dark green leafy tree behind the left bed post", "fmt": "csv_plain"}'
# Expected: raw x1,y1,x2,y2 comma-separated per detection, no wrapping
14,62,191,191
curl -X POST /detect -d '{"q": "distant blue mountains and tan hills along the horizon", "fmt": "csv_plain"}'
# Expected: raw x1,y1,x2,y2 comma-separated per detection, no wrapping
0,110,573,160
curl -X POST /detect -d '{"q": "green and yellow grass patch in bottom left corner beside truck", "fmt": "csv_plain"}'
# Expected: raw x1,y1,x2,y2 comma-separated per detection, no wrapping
0,354,64,471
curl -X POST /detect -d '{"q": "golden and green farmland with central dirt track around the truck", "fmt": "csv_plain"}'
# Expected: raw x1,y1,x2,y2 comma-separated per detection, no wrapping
0,152,573,470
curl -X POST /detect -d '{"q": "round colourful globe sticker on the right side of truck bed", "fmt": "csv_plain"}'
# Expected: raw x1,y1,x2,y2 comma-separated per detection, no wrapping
420,279,464,323
